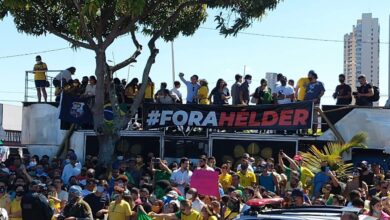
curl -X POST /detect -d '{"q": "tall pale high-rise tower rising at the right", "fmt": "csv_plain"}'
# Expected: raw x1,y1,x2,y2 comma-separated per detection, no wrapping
344,13,380,90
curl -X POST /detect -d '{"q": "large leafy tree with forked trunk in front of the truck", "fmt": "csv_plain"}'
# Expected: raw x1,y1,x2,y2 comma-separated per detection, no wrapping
0,0,280,163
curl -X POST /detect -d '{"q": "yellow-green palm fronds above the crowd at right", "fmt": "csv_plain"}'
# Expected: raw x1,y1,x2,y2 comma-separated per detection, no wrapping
300,132,367,177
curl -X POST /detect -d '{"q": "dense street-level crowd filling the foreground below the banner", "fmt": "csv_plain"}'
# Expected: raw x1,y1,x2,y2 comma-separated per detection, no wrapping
0,150,390,220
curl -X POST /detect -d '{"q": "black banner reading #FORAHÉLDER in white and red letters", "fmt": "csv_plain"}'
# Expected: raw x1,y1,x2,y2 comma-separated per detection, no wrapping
143,102,313,130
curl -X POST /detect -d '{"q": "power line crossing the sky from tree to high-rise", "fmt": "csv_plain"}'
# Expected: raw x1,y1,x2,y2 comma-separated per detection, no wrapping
200,27,389,44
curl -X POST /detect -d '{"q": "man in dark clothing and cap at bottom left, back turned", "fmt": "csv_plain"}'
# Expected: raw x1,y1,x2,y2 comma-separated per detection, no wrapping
20,180,53,220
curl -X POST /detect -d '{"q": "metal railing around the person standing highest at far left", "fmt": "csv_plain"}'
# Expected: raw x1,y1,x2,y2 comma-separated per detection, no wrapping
24,70,62,102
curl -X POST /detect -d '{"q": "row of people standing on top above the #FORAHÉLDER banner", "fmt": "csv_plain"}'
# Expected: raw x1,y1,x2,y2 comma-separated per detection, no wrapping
34,56,375,109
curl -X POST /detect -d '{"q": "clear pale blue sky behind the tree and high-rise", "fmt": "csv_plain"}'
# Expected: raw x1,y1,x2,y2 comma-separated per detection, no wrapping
0,0,390,104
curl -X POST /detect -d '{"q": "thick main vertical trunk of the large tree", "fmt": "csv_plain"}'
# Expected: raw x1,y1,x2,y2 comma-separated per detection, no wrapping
93,50,115,165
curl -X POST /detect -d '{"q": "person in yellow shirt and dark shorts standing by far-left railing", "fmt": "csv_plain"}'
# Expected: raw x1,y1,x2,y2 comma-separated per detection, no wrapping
33,55,47,102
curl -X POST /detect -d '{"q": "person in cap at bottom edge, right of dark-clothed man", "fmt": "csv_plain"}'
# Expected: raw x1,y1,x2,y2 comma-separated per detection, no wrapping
62,185,93,220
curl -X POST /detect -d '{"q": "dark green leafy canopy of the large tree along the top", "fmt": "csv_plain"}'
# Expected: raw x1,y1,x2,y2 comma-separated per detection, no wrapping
0,0,280,48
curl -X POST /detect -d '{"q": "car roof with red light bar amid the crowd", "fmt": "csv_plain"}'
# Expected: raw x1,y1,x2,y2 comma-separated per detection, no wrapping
236,198,361,220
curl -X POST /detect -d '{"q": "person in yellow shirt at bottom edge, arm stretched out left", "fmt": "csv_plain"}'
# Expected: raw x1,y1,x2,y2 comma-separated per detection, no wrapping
151,200,202,220
